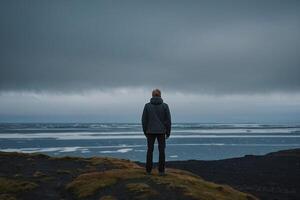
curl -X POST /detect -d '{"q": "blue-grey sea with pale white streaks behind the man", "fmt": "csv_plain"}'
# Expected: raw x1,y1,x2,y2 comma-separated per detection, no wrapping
0,123,300,162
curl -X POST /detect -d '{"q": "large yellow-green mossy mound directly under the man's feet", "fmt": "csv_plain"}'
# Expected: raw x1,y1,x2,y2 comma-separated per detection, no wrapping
67,167,256,200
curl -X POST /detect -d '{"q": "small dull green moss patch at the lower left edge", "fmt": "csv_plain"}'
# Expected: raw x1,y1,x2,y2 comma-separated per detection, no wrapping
0,177,38,194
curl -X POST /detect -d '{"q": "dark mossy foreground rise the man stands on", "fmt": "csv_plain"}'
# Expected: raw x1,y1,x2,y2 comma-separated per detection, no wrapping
0,152,256,200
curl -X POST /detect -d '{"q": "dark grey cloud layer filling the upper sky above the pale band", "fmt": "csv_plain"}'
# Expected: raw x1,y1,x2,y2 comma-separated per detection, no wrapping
0,0,300,93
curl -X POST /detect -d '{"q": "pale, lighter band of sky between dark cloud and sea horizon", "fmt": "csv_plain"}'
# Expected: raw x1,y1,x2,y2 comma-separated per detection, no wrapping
0,88,300,123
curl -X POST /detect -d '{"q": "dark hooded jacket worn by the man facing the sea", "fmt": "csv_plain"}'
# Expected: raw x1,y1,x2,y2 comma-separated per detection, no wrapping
142,97,171,136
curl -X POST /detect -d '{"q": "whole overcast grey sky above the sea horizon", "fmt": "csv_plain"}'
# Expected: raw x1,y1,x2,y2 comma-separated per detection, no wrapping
0,0,300,122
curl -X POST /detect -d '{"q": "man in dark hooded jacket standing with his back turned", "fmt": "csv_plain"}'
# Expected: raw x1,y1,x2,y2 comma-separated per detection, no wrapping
142,89,171,175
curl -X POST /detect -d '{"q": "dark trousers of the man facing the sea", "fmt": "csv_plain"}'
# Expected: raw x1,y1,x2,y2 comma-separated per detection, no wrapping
146,134,166,172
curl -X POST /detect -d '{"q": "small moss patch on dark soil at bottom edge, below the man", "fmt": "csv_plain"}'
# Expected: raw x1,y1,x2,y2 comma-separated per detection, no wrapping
126,183,159,199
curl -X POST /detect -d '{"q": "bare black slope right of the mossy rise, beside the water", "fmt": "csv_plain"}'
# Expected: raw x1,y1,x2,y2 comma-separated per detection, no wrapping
167,149,300,200
